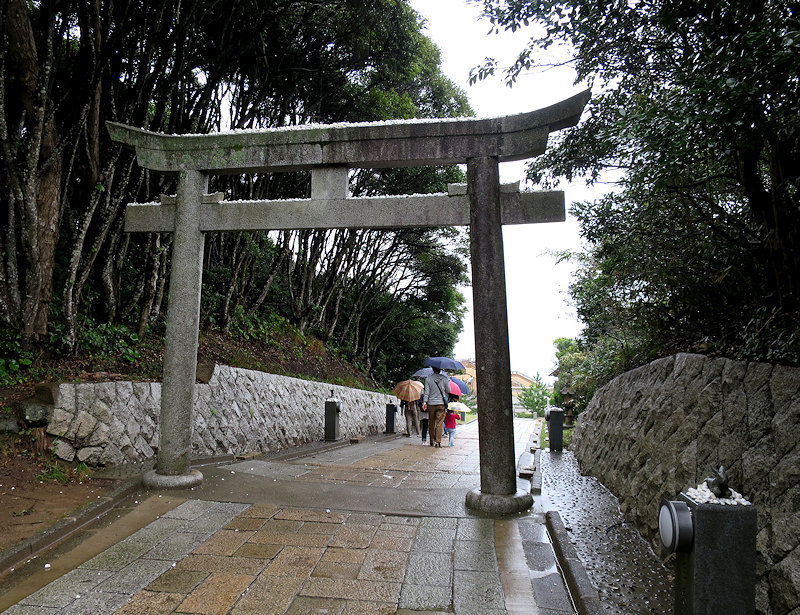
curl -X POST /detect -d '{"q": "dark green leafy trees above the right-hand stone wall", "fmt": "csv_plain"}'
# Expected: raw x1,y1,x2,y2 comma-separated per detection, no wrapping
475,0,800,400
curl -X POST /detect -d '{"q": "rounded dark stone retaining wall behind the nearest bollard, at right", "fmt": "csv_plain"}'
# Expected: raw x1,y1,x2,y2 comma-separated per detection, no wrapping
572,354,800,615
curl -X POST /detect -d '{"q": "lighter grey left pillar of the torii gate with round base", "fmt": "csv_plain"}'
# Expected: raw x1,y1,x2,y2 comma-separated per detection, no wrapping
142,171,208,489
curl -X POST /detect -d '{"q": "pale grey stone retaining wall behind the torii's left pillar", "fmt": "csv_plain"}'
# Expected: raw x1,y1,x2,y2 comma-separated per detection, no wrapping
47,365,397,466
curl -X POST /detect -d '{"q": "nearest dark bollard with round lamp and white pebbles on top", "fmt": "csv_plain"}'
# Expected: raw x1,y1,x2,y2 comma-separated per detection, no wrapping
659,472,757,615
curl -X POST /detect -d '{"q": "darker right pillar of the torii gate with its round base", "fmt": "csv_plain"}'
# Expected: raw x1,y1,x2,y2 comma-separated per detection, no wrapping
466,157,533,514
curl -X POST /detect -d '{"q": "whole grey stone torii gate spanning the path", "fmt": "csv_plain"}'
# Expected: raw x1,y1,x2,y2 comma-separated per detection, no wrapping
108,91,589,514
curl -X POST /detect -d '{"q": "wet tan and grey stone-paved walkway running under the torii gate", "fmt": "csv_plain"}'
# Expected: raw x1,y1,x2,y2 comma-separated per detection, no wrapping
0,419,574,615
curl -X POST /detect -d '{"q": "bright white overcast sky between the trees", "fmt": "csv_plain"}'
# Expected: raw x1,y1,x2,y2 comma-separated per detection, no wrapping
411,0,594,383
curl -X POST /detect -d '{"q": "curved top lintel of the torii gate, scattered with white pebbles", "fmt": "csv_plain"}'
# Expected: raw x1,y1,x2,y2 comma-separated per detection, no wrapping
107,90,590,174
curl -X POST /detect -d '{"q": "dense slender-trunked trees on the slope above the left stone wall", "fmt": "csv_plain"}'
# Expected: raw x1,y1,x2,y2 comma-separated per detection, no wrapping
0,0,473,392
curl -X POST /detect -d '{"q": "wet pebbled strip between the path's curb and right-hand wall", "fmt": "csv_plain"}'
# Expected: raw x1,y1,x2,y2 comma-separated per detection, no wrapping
541,451,673,615
